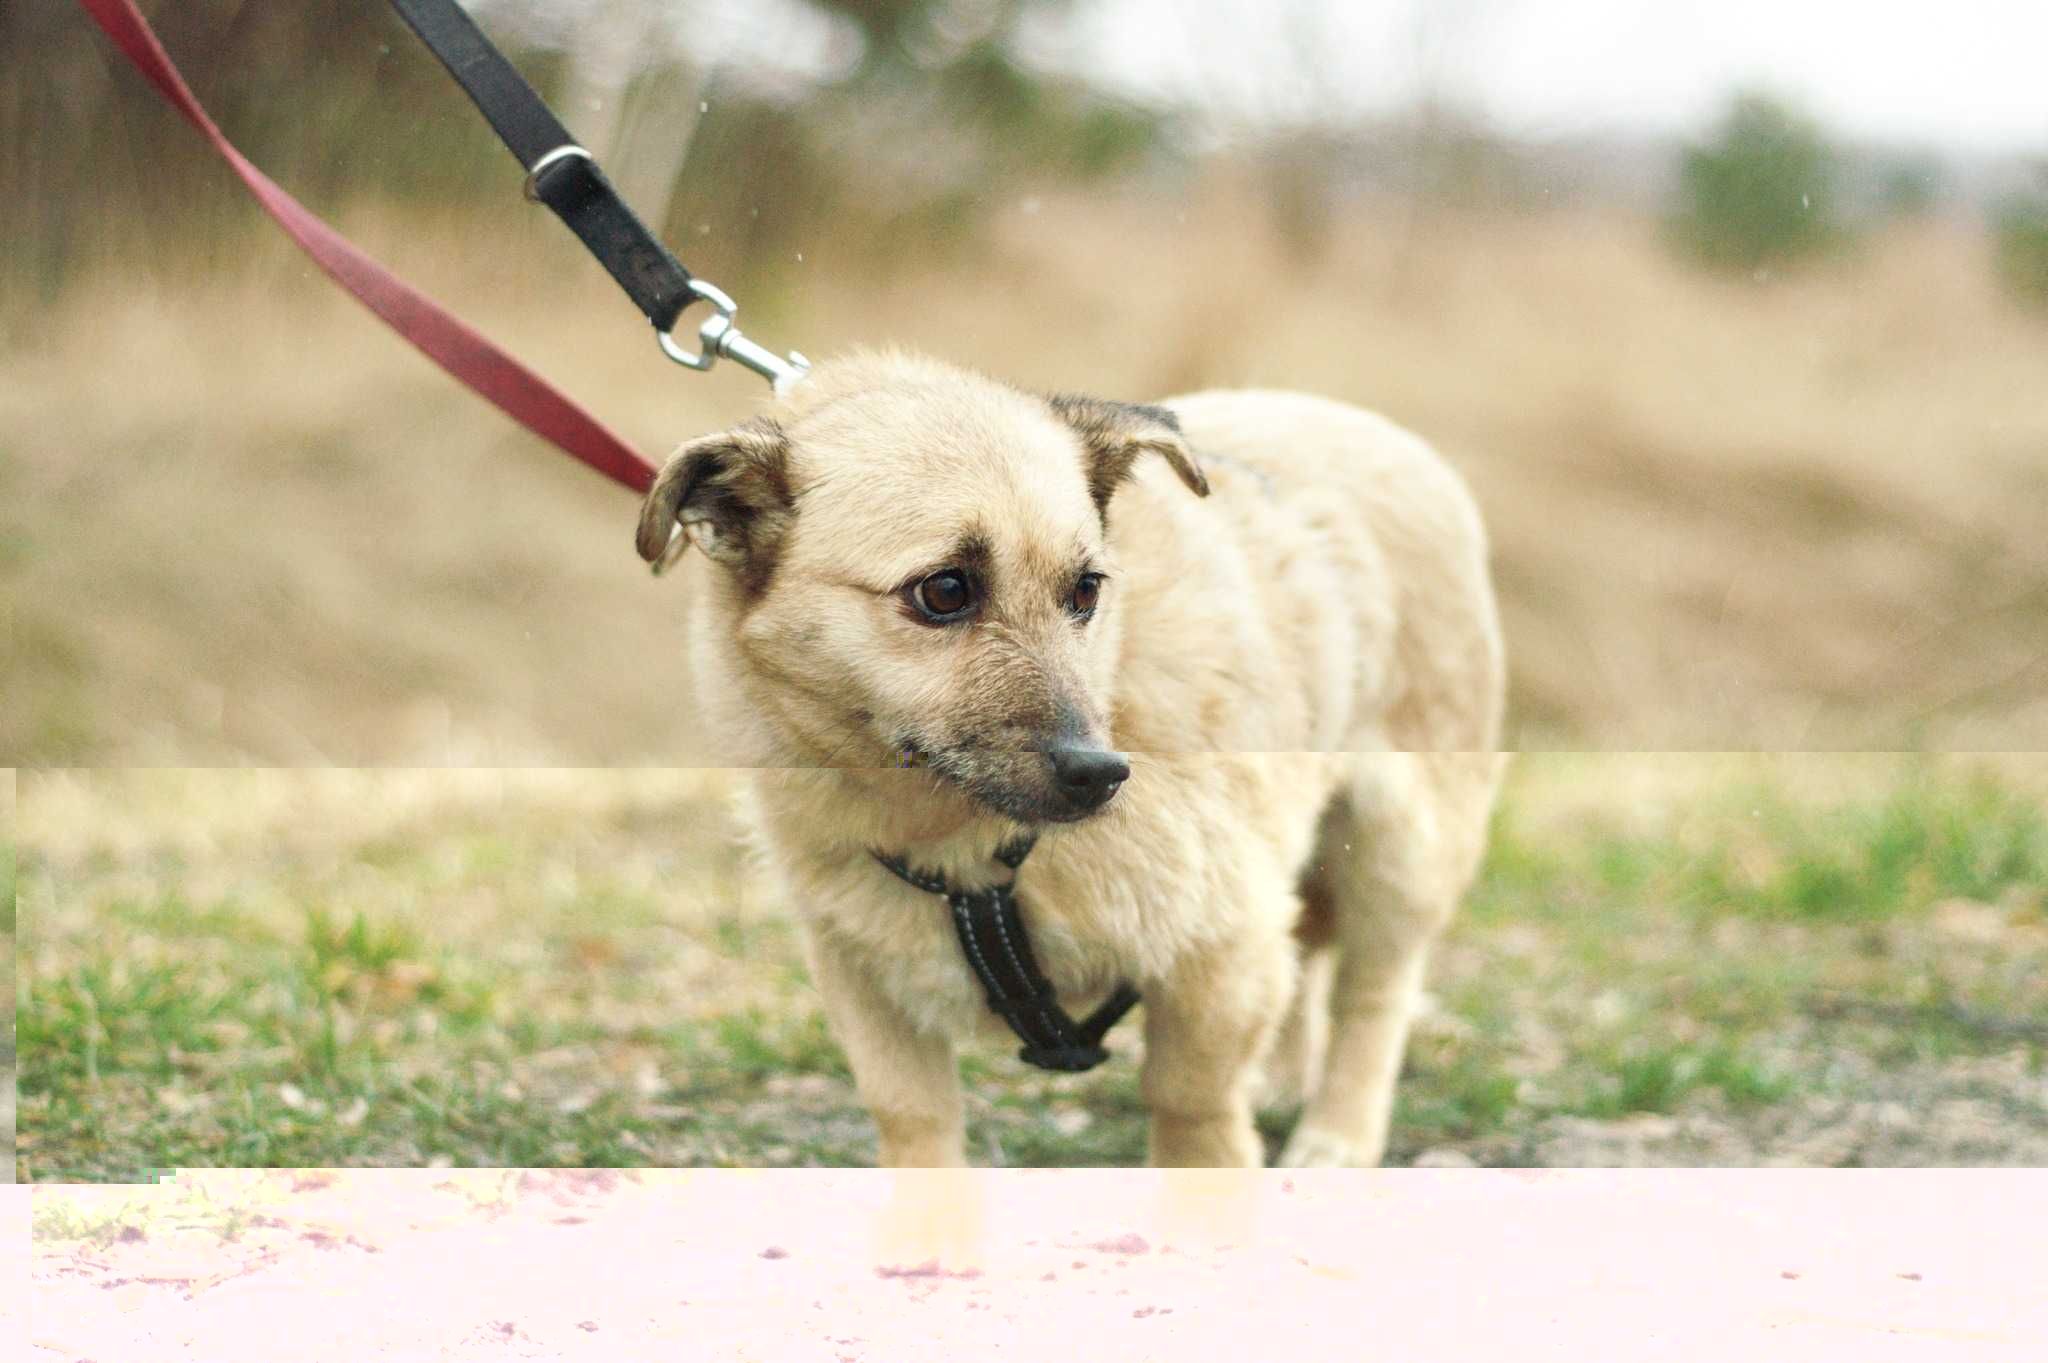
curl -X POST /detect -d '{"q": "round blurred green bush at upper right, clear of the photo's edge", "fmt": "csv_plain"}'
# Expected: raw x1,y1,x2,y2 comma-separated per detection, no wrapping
1671,94,1841,270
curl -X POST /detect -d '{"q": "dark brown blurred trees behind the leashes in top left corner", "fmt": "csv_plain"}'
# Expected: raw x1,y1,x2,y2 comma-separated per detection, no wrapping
0,0,528,297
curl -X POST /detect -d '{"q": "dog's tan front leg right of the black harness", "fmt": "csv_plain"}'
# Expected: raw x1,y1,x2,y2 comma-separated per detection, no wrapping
1143,939,1294,1169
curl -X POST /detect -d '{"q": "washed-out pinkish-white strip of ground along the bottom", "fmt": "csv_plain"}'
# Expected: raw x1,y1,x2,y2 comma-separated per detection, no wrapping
27,1171,2048,1363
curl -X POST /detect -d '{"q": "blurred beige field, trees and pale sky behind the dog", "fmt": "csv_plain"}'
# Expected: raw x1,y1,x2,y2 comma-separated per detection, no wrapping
0,0,2048,763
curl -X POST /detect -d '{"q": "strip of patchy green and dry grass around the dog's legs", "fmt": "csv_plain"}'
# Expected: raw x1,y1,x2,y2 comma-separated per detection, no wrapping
20,755,2048,1181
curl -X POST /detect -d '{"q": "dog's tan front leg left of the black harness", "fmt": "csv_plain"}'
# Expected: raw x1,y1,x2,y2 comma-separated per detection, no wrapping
809,933,967,1169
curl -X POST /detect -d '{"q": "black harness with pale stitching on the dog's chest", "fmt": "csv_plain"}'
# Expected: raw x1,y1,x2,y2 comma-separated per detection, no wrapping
874,835,1139,1074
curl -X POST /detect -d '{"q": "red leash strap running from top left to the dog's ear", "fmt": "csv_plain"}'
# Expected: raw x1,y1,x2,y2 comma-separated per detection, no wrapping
78,0,653,493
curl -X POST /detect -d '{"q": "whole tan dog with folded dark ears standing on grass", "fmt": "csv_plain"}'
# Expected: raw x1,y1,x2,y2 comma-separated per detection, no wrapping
639,354,1503,1167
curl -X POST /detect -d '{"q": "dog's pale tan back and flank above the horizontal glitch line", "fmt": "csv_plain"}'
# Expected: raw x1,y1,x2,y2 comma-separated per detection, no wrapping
1110,391,1505,751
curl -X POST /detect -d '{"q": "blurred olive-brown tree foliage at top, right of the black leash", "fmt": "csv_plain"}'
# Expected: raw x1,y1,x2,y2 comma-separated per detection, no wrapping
666,0,1169,287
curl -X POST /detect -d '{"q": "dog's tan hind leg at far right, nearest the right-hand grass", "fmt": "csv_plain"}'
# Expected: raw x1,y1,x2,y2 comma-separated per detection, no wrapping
1280,753,1499,1167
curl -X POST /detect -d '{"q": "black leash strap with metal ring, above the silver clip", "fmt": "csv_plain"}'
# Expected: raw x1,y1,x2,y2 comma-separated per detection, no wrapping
391,0,698,336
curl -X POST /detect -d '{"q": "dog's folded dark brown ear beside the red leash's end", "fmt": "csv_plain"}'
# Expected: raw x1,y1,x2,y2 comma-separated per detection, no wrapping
635,420,795,581
